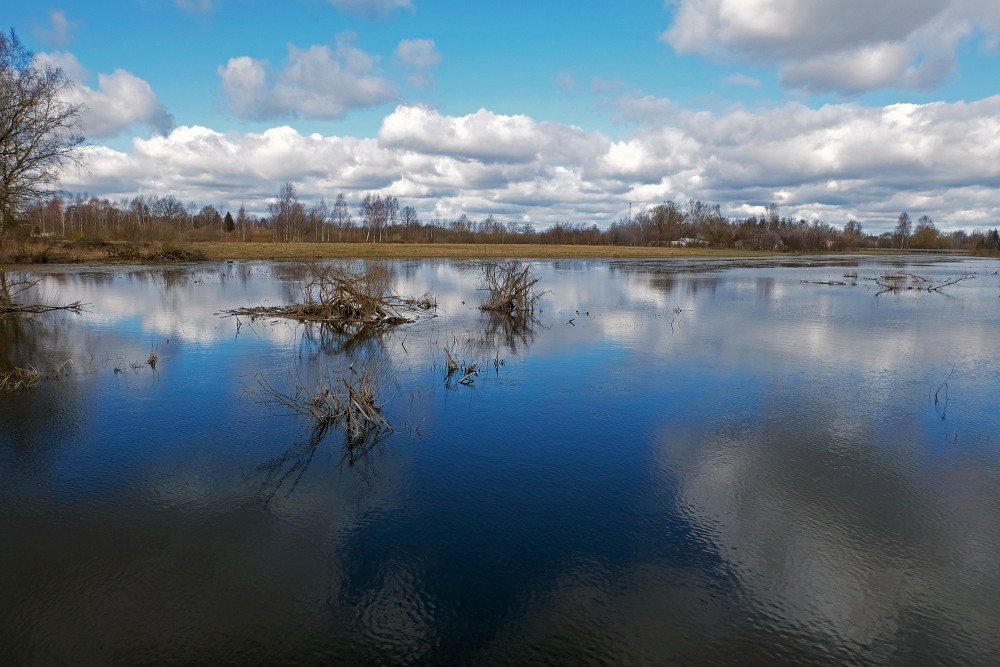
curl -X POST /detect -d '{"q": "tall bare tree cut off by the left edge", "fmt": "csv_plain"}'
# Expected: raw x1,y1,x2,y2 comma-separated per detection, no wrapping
0,30,83,243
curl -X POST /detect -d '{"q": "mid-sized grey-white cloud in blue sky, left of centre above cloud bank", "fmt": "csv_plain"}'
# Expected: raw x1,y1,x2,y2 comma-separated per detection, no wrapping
218,35,399,120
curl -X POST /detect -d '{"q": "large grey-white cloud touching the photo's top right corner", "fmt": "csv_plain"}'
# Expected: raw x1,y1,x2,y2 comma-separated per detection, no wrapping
661,0,1000,95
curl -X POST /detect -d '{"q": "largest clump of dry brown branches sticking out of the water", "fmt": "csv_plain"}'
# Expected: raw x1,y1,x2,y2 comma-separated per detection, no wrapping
223,262,437,333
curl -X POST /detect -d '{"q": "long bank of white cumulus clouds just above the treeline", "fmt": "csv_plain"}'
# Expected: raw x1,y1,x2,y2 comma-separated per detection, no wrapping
64,96,1000,233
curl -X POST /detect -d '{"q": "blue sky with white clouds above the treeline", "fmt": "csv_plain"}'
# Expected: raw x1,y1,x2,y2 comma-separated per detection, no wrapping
0,0,1000,233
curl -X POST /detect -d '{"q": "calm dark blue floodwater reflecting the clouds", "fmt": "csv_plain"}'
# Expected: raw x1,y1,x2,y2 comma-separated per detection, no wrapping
0,258,1000,665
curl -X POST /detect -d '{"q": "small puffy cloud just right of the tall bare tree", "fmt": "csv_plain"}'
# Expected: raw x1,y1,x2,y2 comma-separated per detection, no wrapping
36,52,173,138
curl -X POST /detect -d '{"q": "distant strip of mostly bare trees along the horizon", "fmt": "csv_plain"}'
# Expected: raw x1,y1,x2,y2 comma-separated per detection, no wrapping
15,183,1000,252
